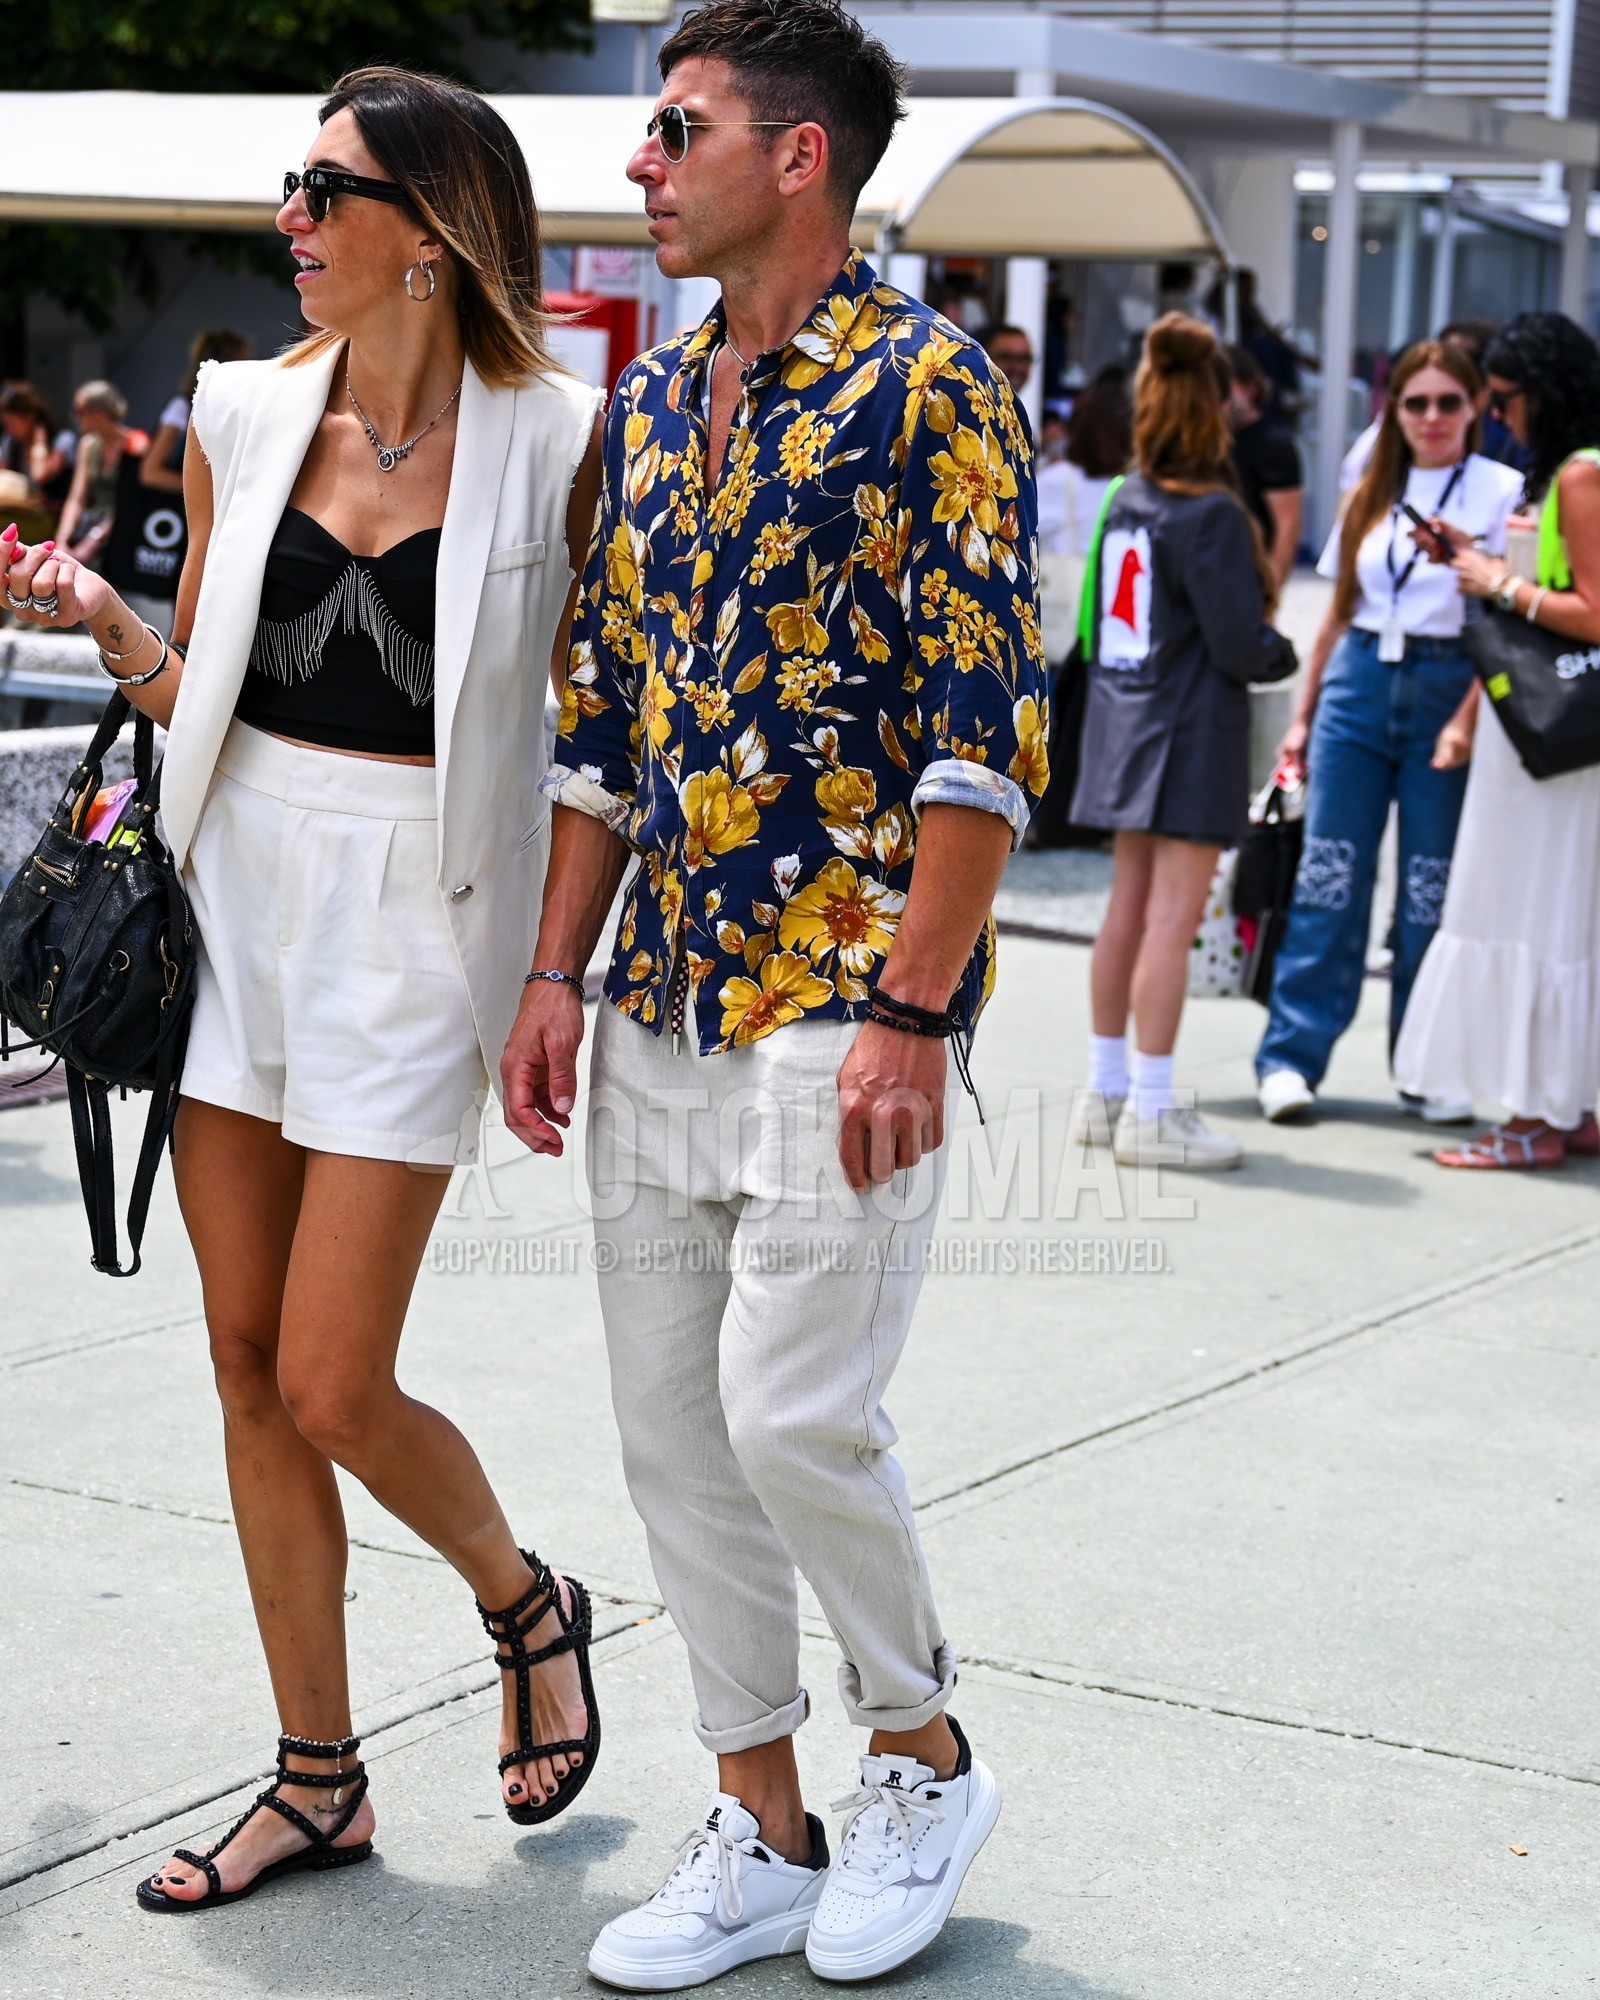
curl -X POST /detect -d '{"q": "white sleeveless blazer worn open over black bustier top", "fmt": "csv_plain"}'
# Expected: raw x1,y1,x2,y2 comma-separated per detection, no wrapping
162,348,604,1082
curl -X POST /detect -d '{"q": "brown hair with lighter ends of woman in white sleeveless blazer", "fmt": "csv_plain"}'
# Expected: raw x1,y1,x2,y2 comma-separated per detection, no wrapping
284,66,560,388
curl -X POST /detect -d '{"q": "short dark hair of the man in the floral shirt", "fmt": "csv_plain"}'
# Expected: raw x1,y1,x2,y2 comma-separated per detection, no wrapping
658,0,906,214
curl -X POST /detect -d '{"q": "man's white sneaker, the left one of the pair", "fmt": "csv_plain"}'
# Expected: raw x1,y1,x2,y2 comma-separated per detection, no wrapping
588,1792,828,1994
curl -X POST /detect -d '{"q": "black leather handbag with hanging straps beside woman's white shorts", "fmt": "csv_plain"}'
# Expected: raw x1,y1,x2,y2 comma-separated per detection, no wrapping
0,694,194,1278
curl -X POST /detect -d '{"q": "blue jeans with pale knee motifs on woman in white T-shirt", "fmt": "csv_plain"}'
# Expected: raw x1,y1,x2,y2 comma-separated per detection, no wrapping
1256,628,1472,1084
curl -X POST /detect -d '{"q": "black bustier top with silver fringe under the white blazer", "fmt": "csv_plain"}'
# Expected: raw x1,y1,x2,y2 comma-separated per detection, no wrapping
234,506,440,756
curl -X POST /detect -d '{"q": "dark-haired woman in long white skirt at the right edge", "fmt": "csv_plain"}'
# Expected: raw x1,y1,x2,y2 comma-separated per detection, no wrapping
1394,312,1600,1170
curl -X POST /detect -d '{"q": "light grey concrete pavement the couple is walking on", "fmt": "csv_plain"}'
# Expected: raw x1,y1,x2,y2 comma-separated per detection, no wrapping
0,916,1600,2000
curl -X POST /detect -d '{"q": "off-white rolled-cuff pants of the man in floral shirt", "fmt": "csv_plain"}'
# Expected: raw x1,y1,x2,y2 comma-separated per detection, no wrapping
588,1000,956,1752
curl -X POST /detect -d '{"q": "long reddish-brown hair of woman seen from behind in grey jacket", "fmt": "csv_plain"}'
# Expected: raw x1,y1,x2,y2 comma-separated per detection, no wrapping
1134,312,1278,618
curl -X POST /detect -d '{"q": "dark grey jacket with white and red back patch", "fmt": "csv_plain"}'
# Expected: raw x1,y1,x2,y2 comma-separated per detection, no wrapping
1072,472,1294,846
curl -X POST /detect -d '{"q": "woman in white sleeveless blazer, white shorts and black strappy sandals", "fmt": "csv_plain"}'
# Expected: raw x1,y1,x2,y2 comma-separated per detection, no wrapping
0,70,600,1912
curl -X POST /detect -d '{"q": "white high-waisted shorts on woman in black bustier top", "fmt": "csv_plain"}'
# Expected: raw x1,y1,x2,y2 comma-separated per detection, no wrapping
182,722,488,1166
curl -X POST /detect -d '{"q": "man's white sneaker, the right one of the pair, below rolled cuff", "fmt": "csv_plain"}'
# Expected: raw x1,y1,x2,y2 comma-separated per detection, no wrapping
806,1718,1000,1980
